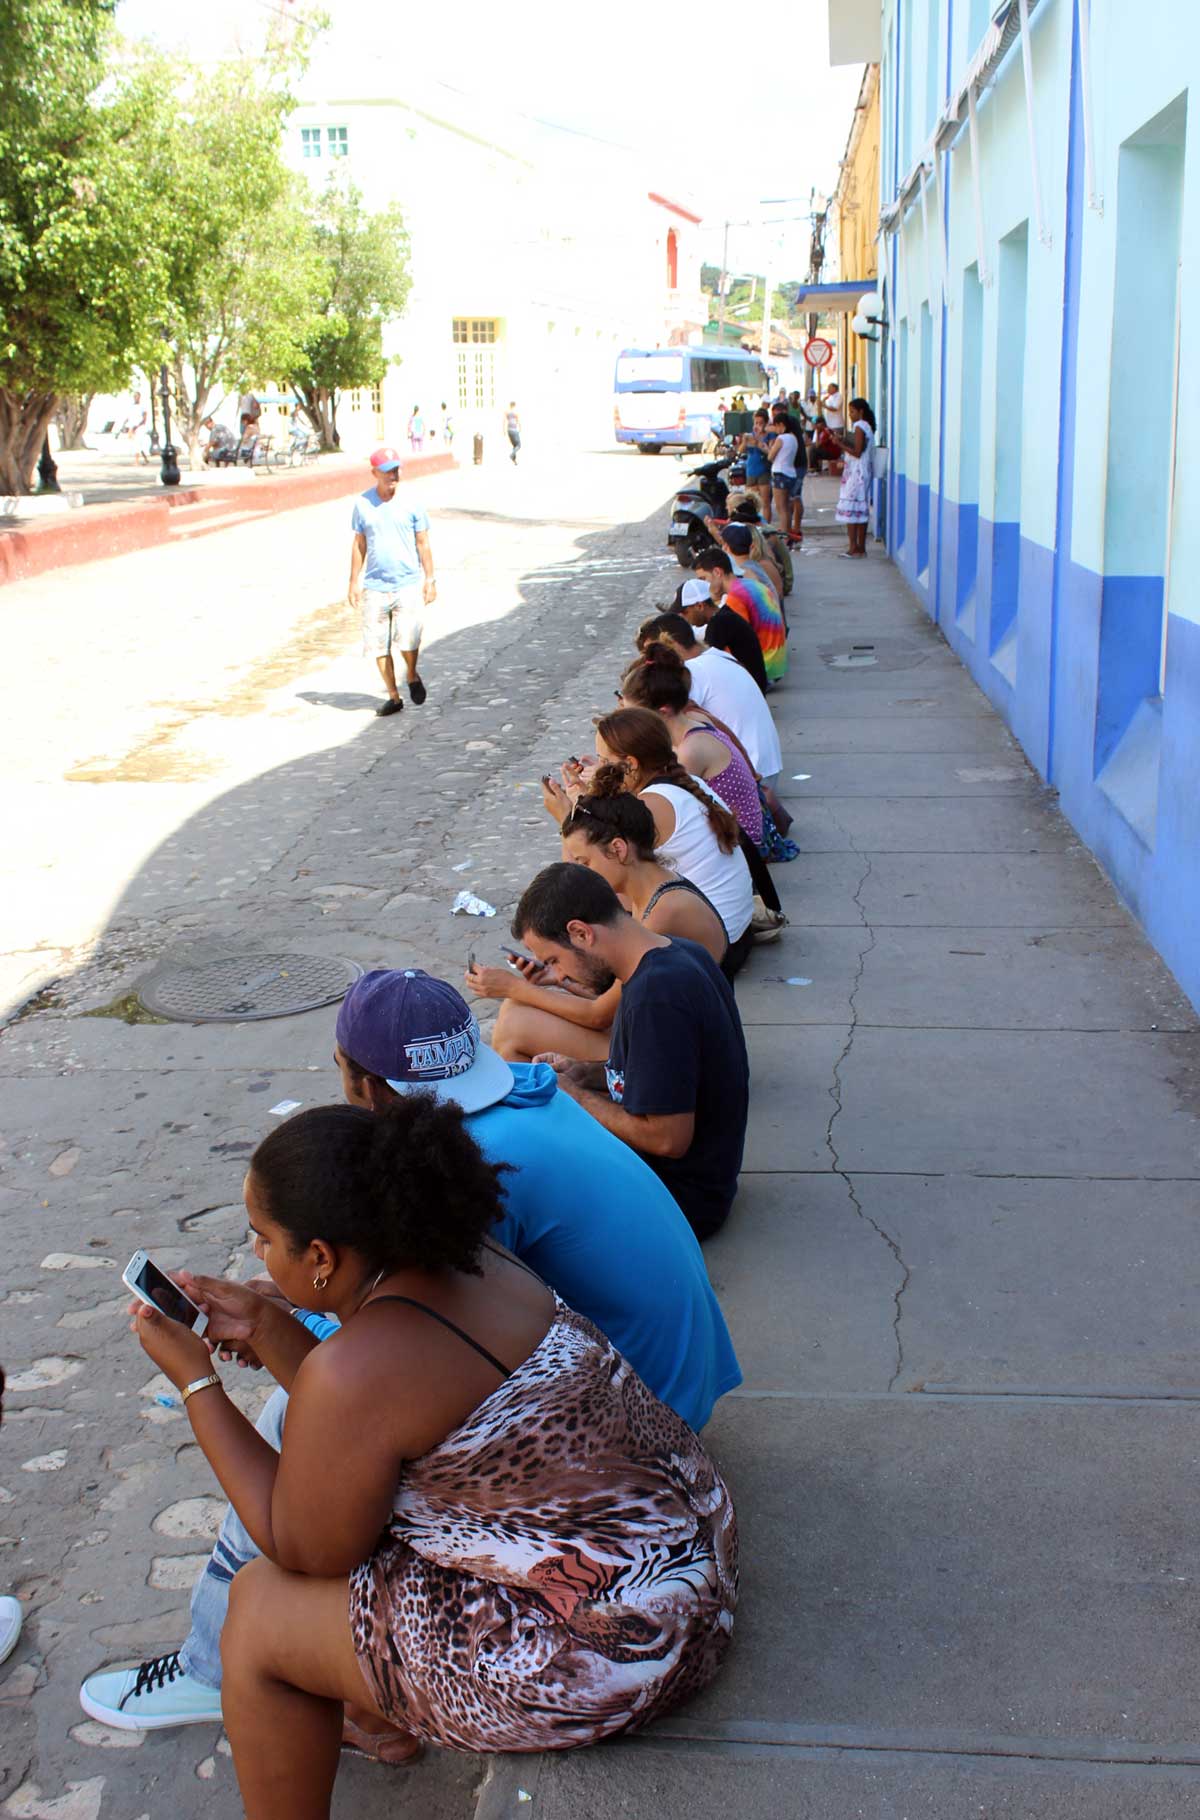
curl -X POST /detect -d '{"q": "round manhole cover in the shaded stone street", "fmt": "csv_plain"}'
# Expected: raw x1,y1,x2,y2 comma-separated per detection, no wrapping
138,954,362,1023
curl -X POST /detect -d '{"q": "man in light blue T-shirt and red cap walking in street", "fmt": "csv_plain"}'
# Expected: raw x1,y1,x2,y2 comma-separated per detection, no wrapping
346,448,437,715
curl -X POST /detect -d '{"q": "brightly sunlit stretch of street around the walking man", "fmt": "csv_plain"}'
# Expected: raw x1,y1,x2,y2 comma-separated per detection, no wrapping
0,434,677,1010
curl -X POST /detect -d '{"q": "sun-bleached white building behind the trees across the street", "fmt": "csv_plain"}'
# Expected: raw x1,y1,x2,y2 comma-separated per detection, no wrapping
288,71,707,453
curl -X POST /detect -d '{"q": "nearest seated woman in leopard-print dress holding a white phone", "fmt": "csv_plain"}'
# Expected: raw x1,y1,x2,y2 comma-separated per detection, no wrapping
89,1092,737,1820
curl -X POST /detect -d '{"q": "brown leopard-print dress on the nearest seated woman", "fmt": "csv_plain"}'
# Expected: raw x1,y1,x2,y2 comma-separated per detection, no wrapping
350,1301,737,1751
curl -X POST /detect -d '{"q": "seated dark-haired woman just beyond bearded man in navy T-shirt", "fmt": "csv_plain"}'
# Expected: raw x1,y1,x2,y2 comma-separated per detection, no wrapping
466,789,737,1061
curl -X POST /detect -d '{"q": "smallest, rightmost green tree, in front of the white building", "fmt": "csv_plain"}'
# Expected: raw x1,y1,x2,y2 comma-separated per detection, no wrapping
290,173,412,448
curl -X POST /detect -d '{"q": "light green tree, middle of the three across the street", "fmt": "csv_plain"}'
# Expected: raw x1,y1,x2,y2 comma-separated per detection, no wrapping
142,53,328,462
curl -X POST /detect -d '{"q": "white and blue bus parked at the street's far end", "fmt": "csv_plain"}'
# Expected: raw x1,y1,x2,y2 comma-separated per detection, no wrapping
612,346,770,455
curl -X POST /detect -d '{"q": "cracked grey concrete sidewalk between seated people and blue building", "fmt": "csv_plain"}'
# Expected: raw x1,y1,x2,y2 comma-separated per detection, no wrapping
483,539,1200,1820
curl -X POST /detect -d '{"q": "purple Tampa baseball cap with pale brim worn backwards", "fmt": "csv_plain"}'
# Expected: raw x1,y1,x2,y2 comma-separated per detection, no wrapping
337,966,514,1112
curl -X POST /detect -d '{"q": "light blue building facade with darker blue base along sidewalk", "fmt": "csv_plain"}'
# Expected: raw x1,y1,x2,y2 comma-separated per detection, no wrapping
874,0,1200,1005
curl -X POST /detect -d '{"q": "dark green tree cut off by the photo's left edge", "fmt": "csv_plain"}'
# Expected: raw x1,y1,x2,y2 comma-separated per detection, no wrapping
0,0,166,493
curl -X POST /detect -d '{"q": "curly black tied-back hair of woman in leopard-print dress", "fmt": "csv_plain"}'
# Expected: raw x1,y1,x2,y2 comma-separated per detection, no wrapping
249,1094,508,1276
